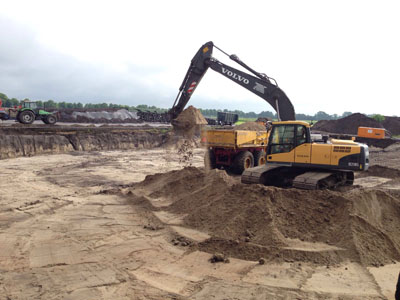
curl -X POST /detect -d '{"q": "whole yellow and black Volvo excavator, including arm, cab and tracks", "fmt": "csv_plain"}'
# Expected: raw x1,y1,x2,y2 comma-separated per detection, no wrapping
169,42,369,189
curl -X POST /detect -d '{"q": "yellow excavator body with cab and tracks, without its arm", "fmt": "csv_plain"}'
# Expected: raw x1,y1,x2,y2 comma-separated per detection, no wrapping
241,121,369,189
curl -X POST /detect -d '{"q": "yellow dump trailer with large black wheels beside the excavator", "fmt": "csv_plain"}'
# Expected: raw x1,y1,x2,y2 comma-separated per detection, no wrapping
201,129,269,174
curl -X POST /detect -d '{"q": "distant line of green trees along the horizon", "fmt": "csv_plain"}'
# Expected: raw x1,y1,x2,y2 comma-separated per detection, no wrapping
0,93,384,121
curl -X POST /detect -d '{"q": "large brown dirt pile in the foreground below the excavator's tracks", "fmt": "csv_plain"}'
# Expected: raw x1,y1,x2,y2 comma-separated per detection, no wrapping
128,167,400,266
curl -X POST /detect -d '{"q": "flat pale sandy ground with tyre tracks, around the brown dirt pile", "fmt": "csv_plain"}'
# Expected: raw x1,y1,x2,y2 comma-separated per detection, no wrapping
0,149,400,300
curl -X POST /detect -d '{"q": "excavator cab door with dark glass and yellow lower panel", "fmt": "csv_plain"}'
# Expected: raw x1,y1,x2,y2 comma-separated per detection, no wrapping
267,124,295,163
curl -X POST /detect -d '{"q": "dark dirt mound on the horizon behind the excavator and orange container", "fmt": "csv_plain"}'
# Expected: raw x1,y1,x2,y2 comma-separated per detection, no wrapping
312,113,383,134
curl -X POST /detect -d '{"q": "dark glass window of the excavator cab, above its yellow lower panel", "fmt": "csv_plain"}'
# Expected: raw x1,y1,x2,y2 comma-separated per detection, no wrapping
268,125,295,154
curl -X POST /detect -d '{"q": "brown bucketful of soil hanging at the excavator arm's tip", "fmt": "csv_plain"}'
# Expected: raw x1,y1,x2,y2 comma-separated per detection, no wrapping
171,105,207,137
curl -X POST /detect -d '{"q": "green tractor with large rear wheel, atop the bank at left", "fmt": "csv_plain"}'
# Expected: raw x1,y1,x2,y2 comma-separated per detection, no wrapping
17,101,57,124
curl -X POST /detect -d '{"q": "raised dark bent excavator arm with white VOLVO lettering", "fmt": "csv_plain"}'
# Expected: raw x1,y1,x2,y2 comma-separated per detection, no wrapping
169,42,295,121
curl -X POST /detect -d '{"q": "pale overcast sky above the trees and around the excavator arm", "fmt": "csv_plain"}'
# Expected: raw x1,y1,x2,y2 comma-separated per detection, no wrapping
0,0,400,115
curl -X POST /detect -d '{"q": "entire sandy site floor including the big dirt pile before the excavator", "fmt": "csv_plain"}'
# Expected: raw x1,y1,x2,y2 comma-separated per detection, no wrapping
0,127,400,300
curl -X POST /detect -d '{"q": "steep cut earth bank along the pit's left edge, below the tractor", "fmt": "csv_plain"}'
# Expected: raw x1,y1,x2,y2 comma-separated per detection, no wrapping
0,126,168,159
